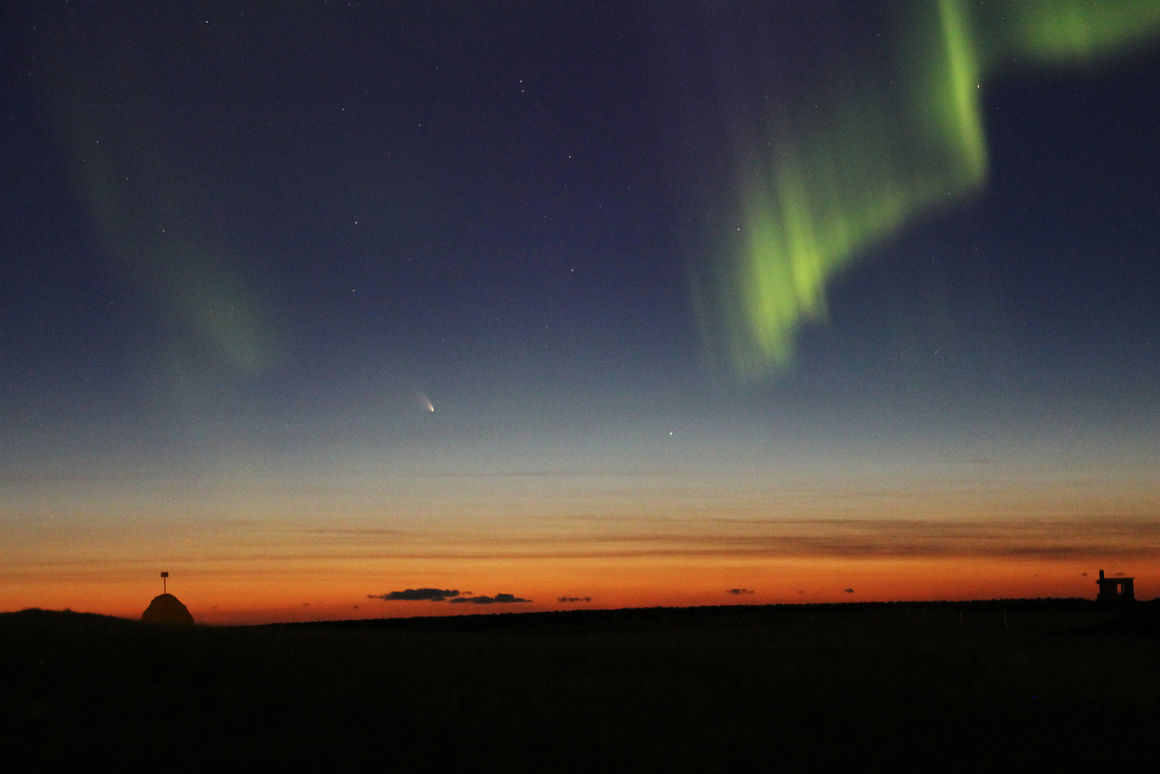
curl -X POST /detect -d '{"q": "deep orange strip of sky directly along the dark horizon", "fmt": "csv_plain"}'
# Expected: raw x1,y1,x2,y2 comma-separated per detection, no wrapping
0,558,1160,624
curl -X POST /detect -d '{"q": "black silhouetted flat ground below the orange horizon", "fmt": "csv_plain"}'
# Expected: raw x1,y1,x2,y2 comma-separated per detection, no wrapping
0,600,1160,772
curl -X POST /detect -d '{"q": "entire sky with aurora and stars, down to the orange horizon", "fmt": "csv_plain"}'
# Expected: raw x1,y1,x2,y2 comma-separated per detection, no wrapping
0,0,1160,622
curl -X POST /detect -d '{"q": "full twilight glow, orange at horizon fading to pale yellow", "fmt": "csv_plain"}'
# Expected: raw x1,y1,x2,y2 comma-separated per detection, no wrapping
0,466,1160,623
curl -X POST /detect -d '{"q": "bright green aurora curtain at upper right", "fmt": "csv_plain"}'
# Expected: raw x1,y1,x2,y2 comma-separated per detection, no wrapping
694,0,1160,378
